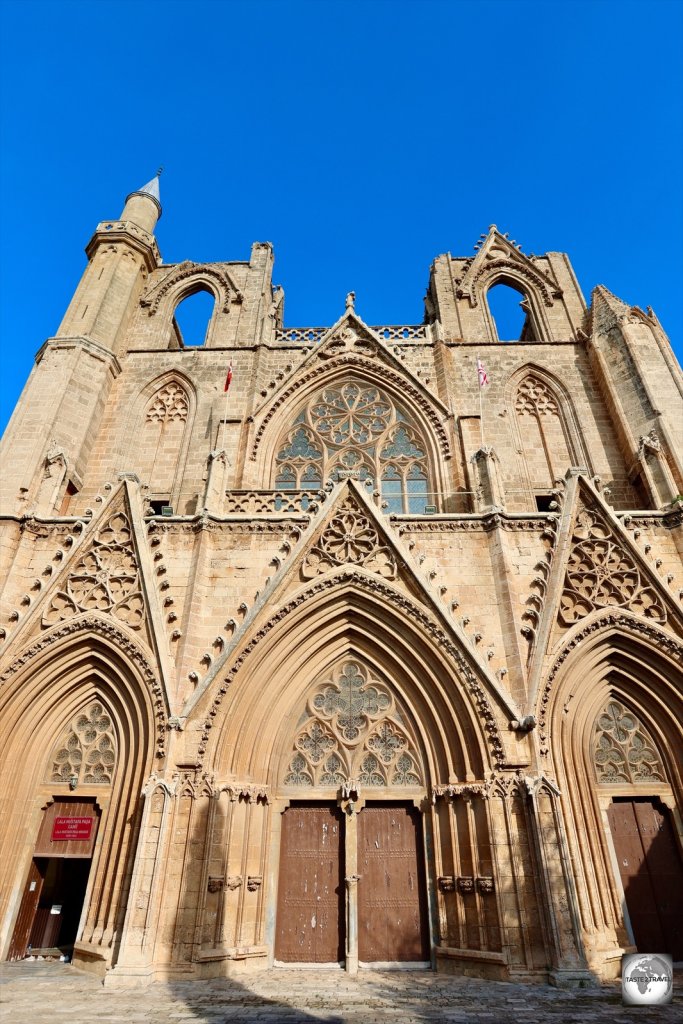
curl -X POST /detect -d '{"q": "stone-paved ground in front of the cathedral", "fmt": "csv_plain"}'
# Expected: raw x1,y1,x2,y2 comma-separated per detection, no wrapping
0,961,683,1024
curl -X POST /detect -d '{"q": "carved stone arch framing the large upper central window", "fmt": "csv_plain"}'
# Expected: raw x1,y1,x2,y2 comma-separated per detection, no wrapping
250,353,451,475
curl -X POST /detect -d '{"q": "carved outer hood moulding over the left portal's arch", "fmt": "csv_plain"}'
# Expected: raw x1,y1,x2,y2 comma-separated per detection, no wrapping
0,615,167,758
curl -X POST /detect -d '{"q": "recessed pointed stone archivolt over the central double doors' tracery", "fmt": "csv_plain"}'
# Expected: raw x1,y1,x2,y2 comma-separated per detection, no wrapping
198,570,504,784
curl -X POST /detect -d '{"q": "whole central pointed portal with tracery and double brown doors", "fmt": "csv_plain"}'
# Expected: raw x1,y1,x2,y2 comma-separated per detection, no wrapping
214,580,489,971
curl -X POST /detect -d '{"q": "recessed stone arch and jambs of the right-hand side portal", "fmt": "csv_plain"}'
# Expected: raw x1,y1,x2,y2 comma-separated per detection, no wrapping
539,612,683,954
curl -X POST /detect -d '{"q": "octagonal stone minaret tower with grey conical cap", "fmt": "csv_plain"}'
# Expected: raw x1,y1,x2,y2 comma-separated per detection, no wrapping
0,171,162,515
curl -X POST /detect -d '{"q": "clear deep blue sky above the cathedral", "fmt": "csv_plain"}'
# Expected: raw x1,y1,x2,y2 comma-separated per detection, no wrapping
0,0,683,429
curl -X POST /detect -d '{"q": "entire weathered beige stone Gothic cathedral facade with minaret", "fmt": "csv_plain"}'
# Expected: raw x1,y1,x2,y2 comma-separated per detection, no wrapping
0,180,683,984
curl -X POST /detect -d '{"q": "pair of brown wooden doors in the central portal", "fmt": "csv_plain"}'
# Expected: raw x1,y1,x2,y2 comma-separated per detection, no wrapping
275,803,429,965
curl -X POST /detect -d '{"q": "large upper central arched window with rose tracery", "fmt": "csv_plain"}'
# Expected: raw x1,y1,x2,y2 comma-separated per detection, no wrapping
274,380,430,514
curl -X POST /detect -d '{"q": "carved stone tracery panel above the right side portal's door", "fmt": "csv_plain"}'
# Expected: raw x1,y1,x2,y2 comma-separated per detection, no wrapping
593,700,666,785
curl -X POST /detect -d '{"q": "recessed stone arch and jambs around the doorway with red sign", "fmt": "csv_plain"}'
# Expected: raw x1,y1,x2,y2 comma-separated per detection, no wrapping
0,616,158,963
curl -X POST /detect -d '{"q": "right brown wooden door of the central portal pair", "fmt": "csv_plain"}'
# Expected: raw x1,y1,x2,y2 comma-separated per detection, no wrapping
358,805,429,964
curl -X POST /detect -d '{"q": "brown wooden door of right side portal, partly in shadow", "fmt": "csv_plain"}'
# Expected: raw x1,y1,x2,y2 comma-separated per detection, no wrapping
608,799,683,961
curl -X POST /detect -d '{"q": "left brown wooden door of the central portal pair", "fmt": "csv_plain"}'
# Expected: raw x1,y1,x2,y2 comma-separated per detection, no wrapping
275,804,344,964
